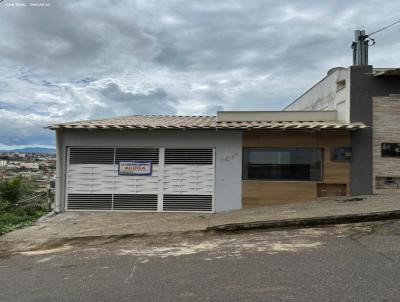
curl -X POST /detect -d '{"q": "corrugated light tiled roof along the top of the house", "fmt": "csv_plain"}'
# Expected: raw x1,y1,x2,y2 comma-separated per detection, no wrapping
47,115,366,130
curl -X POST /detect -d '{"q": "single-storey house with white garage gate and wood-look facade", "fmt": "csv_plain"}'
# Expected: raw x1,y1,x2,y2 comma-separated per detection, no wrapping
50,111,365,212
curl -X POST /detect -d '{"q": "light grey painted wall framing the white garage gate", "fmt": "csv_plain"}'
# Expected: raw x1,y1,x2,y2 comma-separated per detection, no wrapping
56,129,242,211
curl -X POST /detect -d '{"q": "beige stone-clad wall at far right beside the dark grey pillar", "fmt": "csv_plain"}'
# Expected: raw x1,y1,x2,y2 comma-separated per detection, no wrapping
372,97,400,188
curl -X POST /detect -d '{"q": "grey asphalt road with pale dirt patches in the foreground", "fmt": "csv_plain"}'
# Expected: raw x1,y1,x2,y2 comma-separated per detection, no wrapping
0,221,400,302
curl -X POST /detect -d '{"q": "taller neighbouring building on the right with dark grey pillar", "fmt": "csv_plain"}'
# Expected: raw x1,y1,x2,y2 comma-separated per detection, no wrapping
284,65,400,195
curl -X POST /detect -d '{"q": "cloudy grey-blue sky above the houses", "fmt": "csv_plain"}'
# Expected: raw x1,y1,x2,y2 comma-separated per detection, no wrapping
0,0,400,149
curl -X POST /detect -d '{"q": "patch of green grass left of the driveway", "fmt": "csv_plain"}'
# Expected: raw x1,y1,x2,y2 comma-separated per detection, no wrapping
0,203,48,235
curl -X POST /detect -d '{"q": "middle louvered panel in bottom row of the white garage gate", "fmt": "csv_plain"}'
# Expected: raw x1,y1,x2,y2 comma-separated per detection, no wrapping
114,194,158,211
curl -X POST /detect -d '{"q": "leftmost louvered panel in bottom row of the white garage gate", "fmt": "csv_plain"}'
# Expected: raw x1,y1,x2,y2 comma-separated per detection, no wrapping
68,194,112,210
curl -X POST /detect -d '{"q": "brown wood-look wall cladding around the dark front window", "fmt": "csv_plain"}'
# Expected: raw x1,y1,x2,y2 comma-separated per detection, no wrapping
242,130,350,208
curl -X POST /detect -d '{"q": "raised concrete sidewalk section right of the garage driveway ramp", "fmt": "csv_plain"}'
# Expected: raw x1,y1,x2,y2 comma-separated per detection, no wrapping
208,190,400,230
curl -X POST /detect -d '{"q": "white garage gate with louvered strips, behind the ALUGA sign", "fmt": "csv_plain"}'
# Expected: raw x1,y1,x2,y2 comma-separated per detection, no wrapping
66,147,215,212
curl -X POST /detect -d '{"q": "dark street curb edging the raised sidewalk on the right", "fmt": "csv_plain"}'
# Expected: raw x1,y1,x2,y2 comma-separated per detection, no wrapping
206,210,400,231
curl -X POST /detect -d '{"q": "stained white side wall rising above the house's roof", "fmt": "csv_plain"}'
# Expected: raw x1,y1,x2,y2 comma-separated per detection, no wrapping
284,68,350,122
